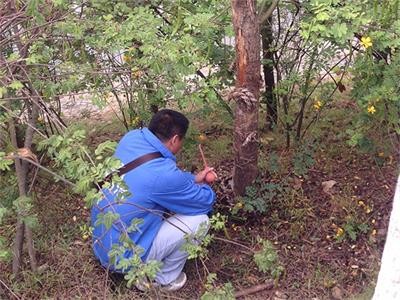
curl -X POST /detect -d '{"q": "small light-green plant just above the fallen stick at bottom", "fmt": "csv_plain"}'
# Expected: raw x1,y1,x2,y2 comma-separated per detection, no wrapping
254,238,285,280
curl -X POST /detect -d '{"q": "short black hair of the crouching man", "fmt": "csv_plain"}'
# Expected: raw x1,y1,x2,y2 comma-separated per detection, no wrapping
149,109,189,142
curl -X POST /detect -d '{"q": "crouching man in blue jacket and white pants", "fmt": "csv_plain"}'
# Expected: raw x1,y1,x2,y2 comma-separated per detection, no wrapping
91,109,215,291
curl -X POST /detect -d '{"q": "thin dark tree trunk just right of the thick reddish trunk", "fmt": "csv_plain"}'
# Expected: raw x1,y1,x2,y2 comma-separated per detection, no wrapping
261,16,278,130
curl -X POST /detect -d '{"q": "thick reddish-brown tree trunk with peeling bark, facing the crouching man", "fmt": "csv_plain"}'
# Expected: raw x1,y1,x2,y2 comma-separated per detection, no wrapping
231,0,261,196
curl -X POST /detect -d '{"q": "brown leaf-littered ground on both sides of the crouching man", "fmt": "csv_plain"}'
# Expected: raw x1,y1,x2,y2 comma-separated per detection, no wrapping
0,113,398,299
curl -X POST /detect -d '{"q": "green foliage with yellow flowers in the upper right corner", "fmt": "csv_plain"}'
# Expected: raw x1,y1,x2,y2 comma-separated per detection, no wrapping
301,0,400,151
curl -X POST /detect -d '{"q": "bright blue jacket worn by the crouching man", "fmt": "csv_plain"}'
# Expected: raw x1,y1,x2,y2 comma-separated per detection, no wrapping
91,128,215,271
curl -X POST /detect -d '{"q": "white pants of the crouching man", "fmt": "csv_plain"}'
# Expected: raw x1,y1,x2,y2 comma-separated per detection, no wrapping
146,215,208,285
